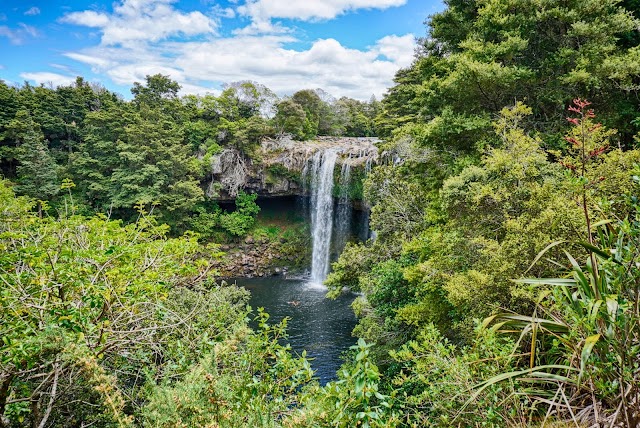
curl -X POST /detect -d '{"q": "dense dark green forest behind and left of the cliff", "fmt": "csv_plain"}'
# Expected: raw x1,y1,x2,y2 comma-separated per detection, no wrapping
0,75,379,236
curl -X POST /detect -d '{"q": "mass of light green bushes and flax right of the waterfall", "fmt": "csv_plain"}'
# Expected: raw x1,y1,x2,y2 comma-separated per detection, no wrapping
327,91,639,426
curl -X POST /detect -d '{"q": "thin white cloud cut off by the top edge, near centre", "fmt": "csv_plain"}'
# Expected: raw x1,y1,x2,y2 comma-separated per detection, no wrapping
238,0,407,21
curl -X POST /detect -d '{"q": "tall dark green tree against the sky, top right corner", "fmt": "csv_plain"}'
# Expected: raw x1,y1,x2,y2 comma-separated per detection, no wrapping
376,0,640,147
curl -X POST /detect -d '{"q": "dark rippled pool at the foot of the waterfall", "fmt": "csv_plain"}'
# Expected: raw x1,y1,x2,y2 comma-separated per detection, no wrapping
230,276,356,384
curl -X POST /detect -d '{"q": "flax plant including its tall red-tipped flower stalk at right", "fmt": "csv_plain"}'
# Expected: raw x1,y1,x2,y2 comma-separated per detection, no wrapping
480,100,640,427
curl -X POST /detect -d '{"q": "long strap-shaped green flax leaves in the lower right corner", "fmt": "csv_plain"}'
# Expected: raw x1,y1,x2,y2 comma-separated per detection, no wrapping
487,202,640,426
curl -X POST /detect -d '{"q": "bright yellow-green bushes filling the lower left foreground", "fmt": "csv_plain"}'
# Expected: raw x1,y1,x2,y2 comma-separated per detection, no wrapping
0,182,318,427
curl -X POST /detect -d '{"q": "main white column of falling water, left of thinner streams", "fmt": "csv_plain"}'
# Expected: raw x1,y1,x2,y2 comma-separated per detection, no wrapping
311,149,338,287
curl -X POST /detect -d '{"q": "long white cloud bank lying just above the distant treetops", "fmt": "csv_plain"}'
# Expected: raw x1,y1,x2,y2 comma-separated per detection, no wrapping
66,31,413,100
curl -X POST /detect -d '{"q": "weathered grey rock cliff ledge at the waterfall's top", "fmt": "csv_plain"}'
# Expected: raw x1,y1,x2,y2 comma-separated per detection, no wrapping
206,137,378,200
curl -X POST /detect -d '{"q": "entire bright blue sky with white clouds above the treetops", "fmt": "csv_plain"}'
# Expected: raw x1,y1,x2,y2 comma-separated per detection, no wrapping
0,0,443,99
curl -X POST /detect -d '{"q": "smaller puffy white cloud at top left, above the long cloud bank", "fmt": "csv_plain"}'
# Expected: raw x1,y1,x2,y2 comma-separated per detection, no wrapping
61,0,217,45
